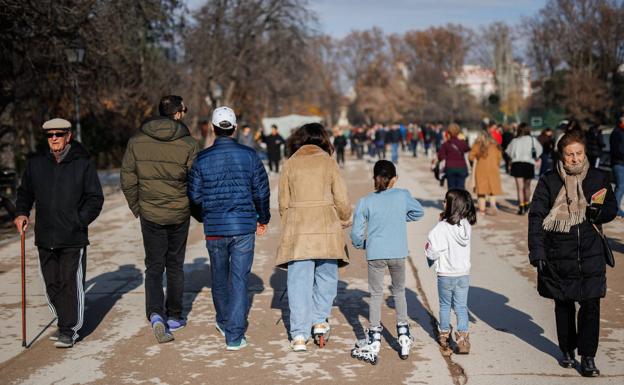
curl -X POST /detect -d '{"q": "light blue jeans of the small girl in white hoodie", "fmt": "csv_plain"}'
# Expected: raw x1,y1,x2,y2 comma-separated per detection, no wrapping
438,275,470,332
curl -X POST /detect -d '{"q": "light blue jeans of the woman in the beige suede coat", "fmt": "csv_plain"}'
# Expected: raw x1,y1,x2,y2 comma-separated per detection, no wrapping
287,259,338,339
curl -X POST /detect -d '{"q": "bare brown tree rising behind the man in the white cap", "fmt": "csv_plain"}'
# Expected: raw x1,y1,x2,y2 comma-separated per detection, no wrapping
185,0,313,124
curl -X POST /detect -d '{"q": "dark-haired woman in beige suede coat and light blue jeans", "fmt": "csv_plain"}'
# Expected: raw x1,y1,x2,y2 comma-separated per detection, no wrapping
276,123,351,351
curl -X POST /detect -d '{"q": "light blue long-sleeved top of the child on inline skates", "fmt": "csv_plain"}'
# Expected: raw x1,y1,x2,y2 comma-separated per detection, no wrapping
351,188,424,261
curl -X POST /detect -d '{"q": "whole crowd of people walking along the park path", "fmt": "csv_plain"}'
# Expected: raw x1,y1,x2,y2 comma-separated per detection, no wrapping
15,95,624,376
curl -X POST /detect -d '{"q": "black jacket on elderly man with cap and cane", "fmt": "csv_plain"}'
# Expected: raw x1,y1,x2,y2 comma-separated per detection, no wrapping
16,141,104,249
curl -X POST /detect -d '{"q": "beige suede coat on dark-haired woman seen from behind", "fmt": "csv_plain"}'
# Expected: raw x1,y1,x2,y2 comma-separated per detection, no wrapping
275,145,351,267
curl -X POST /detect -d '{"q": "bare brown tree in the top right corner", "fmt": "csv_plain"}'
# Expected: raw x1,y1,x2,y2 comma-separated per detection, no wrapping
525,0,624,121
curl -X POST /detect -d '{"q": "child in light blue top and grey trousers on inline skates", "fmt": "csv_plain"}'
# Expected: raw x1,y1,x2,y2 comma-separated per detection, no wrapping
351,160,424,364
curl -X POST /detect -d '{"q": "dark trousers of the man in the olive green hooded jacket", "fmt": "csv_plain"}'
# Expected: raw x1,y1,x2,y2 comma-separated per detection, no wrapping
141,218,189,319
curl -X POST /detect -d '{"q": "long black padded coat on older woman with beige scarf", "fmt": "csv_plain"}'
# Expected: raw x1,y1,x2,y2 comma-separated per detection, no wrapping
529,168,617,301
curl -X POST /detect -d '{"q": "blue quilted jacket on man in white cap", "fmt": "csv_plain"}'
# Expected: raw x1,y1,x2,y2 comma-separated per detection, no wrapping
187,137,271,236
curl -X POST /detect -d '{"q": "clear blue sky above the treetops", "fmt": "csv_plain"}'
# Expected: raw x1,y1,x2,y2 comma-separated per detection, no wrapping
185,0,546,38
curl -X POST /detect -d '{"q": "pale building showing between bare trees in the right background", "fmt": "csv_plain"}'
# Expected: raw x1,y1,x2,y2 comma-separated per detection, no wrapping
455,63,532,101
